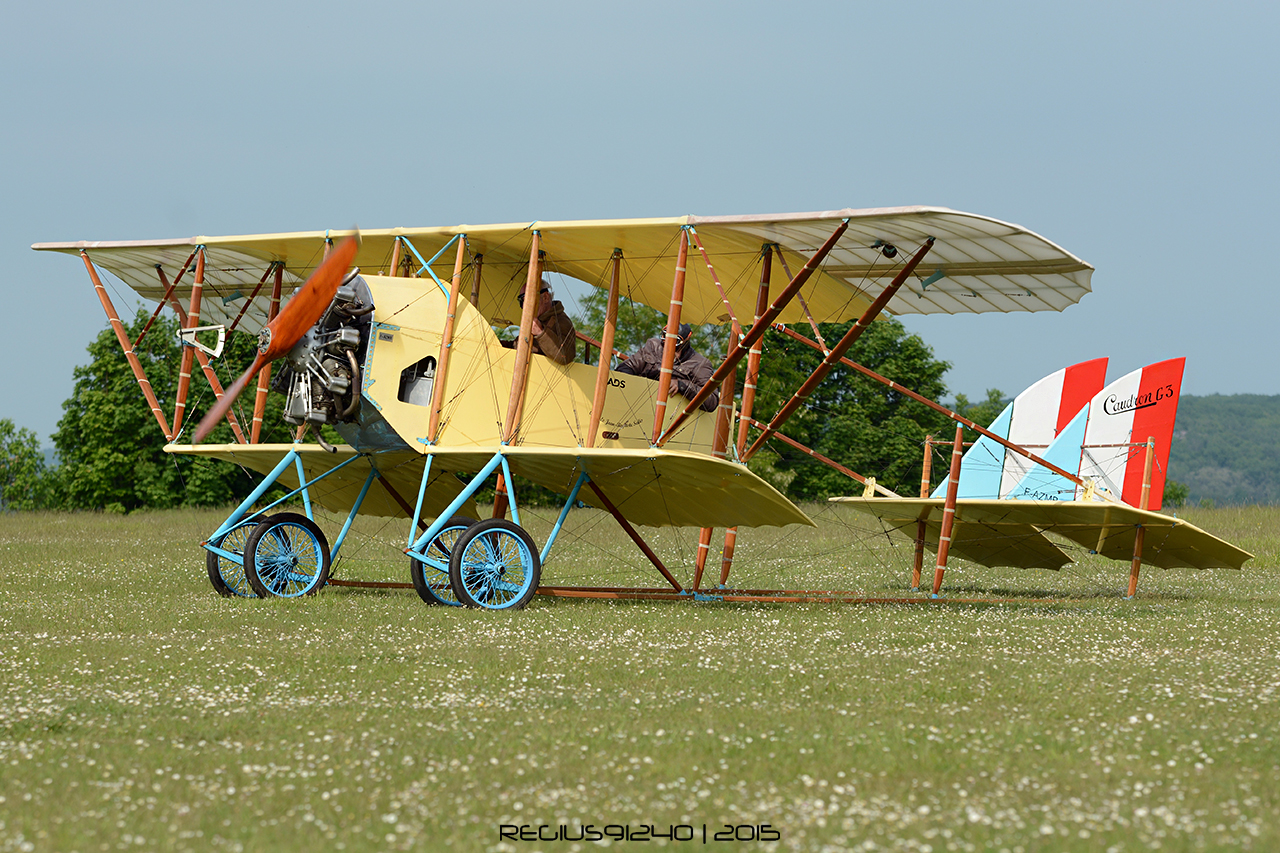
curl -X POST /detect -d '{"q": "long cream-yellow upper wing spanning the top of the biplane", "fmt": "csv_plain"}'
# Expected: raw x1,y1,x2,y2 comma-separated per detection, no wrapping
32,207,1093,332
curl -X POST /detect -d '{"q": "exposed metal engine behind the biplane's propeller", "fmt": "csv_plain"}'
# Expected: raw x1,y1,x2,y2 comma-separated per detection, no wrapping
273,269,374,445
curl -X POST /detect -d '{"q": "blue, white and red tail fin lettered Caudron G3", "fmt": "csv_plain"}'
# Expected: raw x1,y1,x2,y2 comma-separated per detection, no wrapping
1009,359,1187,508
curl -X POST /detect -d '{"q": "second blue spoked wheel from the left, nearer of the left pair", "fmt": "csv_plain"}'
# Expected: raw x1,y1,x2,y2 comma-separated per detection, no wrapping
244,512,329,598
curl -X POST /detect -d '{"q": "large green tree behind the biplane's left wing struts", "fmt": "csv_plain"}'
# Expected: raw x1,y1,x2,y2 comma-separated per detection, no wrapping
54,311,291,512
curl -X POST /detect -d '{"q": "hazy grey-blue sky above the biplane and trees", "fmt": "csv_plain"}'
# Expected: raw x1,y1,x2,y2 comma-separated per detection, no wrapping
0,0,1280,439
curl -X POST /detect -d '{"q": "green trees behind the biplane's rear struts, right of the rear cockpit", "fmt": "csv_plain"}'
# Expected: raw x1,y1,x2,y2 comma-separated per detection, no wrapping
739,318,951,500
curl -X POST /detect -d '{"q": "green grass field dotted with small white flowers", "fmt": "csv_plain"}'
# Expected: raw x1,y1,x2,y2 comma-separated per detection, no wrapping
0,507,1280,852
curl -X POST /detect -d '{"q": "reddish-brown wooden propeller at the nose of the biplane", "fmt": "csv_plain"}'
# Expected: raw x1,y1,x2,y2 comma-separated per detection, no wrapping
191,237,360,444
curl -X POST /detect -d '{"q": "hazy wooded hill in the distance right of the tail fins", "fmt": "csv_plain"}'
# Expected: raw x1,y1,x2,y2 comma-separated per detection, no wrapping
1169,394,1280,505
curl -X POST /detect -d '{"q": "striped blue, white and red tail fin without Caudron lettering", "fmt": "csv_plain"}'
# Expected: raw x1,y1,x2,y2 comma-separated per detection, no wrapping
932,359,1107,498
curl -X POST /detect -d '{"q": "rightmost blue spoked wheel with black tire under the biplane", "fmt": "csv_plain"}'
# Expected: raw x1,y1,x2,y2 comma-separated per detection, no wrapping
449,519,543,610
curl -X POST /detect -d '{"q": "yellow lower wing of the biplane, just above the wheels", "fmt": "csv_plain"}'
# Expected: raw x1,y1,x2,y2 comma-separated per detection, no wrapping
165,444,813,528
